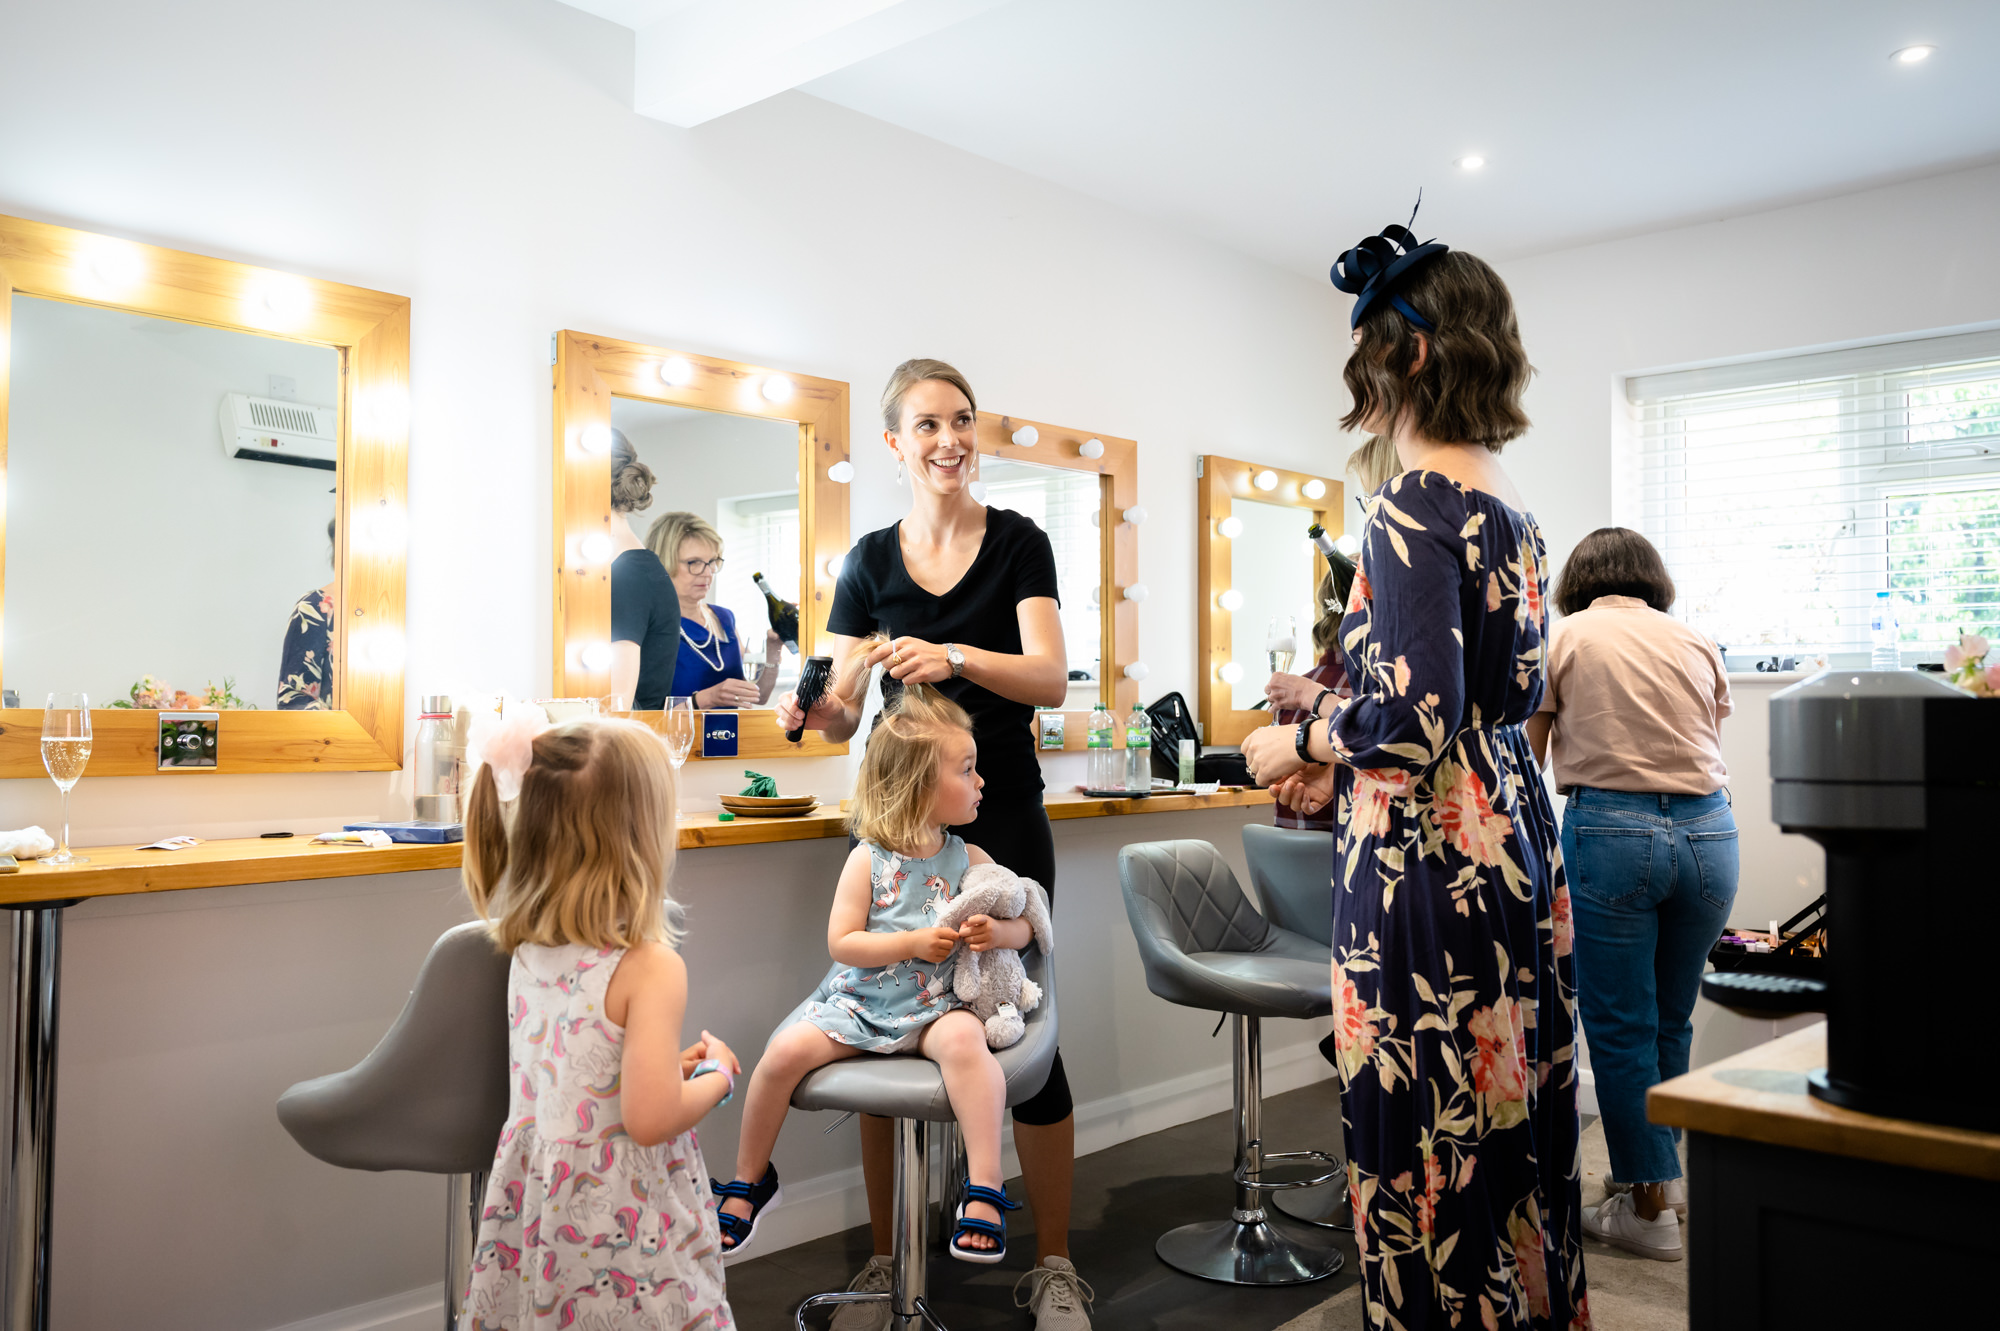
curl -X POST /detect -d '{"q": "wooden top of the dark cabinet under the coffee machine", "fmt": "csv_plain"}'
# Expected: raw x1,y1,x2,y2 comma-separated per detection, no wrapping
1646,1021,2000,1181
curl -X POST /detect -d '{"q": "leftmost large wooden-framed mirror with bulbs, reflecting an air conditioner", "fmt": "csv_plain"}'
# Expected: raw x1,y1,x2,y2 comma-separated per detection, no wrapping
0,218,410,775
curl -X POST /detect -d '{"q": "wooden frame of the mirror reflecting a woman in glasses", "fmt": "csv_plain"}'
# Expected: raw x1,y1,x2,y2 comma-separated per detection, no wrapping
550,330,848,761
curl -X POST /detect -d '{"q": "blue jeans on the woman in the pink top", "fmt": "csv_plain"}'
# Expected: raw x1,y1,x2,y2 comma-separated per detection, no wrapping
1562,785,1738,1183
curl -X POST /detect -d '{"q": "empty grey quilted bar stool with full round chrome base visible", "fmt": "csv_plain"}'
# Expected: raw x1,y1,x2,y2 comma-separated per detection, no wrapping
1118,841,1342,1285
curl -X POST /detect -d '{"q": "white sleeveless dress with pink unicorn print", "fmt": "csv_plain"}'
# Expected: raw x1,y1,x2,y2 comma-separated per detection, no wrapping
458,943,736,1331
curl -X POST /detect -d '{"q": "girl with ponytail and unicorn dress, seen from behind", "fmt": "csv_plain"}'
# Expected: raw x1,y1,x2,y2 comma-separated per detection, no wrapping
458,719,742,1329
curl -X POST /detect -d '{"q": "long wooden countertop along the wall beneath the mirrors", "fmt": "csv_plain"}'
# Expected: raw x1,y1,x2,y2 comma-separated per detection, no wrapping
15,789,1270,903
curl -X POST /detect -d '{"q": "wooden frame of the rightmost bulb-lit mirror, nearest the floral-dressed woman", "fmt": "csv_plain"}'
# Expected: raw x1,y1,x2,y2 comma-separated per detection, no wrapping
1194,454,1346,745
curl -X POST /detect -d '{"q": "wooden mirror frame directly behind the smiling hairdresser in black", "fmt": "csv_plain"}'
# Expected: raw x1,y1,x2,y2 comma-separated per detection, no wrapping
974,412,1140,727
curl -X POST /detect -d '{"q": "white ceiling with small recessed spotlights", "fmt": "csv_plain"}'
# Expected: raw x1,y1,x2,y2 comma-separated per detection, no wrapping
572,0,2000,276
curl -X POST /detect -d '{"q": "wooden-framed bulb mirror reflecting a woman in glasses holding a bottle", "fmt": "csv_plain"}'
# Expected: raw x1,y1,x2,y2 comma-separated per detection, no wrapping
554,332,854,757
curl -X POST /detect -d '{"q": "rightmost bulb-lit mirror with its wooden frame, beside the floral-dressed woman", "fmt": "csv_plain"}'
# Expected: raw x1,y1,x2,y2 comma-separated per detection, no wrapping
1196,454,1346,743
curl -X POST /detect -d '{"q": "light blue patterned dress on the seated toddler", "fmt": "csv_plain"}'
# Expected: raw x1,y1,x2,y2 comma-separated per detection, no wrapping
804,831,970,1053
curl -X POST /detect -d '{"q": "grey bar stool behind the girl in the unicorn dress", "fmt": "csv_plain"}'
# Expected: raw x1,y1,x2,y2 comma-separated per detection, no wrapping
278,923,510,1331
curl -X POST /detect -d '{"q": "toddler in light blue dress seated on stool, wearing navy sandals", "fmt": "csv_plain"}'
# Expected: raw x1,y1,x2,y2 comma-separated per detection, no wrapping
716,685,1030,1263
